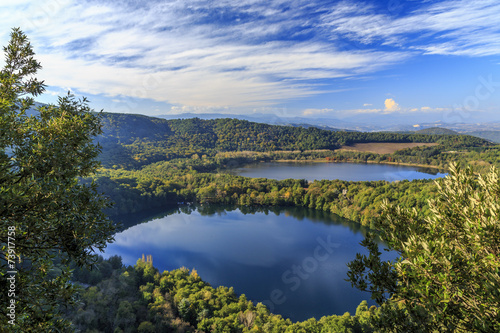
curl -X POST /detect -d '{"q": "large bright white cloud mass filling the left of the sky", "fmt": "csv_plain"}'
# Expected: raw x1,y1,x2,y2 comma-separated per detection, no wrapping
0,0,408,108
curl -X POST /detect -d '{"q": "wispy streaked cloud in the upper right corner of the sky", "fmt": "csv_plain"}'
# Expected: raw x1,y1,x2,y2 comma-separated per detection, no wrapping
322,0,500,56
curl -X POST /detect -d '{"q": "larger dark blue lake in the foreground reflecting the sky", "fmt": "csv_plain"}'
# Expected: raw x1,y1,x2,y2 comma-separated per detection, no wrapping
106,205,394,320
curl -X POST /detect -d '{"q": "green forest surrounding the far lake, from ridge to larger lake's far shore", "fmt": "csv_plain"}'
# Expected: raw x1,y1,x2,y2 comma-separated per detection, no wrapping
95,113,500,219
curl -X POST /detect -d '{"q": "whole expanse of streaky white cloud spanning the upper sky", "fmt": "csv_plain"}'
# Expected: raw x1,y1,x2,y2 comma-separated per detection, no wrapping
0,0,500,110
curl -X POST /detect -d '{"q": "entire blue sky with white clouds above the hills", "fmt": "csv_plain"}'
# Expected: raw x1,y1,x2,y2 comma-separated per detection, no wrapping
0,0,500,122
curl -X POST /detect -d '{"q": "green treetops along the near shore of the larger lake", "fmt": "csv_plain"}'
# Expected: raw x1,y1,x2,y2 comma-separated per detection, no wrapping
66,256,378,333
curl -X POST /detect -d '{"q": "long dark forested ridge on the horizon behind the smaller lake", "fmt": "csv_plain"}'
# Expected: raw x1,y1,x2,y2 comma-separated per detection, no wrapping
96,113,490,169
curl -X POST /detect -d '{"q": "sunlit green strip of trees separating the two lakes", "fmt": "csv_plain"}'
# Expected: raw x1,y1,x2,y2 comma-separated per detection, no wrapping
97,157,436,226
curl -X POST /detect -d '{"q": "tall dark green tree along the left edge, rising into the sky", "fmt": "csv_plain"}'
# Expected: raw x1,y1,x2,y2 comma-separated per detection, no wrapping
0,28,114,332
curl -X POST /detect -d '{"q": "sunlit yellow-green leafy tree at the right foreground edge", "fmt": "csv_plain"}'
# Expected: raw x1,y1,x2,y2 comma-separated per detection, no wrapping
348,165,500,332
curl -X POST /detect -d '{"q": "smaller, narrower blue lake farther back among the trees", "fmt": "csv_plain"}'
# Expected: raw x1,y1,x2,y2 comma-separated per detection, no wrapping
230,162,447,182
